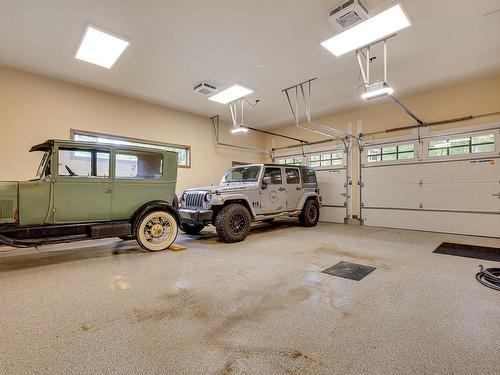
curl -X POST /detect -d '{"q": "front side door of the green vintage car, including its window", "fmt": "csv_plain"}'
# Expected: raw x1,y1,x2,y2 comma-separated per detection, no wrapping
53,145,112,224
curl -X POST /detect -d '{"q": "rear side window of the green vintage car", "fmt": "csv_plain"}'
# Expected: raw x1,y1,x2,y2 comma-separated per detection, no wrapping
115,151,163,179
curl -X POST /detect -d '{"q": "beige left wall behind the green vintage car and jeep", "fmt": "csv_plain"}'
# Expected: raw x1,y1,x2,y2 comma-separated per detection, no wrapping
0,67,265,192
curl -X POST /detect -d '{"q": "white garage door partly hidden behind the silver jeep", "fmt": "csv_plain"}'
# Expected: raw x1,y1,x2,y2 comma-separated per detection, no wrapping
275,148,350,223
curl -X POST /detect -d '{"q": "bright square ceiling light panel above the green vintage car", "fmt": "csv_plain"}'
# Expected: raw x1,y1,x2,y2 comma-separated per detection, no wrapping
75,25,130,69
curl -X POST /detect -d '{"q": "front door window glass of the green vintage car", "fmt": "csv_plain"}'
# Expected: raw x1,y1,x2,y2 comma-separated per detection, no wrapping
58,148,109,178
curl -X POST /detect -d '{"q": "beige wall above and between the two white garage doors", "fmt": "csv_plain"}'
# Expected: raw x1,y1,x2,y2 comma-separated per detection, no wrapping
266,75,500,214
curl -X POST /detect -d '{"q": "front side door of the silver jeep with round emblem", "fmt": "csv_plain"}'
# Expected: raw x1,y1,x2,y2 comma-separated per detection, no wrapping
260,167,286,214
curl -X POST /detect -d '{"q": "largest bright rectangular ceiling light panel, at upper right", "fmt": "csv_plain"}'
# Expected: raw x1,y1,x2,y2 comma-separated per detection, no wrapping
321,4,411,56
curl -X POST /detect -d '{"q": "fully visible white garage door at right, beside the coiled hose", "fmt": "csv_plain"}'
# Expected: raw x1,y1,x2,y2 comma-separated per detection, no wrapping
361,127,500,237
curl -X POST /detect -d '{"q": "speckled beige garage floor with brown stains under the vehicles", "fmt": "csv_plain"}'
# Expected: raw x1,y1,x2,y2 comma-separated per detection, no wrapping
0,224,500,374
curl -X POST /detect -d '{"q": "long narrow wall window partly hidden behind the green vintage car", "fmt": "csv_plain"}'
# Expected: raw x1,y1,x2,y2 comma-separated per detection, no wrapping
73,130,191,167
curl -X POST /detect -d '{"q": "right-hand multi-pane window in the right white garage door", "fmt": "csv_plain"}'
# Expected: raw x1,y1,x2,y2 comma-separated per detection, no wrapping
429,134,495,157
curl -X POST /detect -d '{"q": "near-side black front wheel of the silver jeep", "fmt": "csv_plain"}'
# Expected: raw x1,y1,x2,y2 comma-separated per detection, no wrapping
215,203,252,242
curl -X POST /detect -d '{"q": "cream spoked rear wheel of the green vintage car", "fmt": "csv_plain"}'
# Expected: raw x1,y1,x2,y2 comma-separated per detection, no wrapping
135,211,178,251
